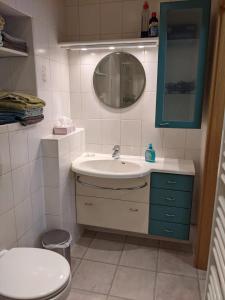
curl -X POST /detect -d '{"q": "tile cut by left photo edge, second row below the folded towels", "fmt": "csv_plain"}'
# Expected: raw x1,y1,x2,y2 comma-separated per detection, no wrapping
0,173,13,215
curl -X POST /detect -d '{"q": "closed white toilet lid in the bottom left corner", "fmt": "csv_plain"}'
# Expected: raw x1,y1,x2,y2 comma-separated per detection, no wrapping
0,248,70,299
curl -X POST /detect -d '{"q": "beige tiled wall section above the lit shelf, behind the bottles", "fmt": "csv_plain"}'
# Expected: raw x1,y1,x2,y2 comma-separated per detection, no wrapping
63,0,167,40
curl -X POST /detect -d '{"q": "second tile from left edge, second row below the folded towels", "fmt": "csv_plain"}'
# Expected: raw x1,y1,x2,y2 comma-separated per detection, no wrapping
12,165,30,205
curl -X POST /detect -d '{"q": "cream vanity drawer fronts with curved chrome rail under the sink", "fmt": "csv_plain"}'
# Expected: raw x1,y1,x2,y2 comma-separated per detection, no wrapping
76,175,150,234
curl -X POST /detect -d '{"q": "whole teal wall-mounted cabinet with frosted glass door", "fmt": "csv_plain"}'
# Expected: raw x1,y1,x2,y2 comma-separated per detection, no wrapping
155,0,210,128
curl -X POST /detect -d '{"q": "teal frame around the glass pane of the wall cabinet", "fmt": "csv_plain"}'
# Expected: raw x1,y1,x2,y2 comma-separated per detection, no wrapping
155,0,211,128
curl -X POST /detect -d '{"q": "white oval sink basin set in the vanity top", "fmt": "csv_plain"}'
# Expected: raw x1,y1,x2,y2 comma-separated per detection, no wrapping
72,154,150,178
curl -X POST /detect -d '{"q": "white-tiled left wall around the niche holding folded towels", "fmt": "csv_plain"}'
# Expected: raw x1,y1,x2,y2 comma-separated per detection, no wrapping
0,0,70,248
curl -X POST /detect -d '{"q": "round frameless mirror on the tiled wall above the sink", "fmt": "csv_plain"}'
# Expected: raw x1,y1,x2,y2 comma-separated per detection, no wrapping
93,52,146,108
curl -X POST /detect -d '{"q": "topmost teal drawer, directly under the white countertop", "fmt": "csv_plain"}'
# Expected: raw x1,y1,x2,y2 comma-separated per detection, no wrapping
151,173,194,192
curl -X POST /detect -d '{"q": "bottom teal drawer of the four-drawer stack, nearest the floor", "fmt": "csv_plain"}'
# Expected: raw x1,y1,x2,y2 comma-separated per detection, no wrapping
149,220,190,240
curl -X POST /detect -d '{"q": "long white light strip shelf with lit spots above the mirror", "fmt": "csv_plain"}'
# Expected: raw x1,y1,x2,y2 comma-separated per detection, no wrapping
59,38,159,51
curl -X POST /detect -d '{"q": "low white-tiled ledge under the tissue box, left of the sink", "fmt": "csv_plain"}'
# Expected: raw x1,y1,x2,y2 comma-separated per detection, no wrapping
42,128,85,239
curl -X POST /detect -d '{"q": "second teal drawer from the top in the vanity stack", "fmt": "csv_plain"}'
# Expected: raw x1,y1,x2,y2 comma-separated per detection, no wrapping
150,188,192,208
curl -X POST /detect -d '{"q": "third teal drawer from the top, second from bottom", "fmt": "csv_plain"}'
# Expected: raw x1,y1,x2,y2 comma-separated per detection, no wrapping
150,205,191,225
